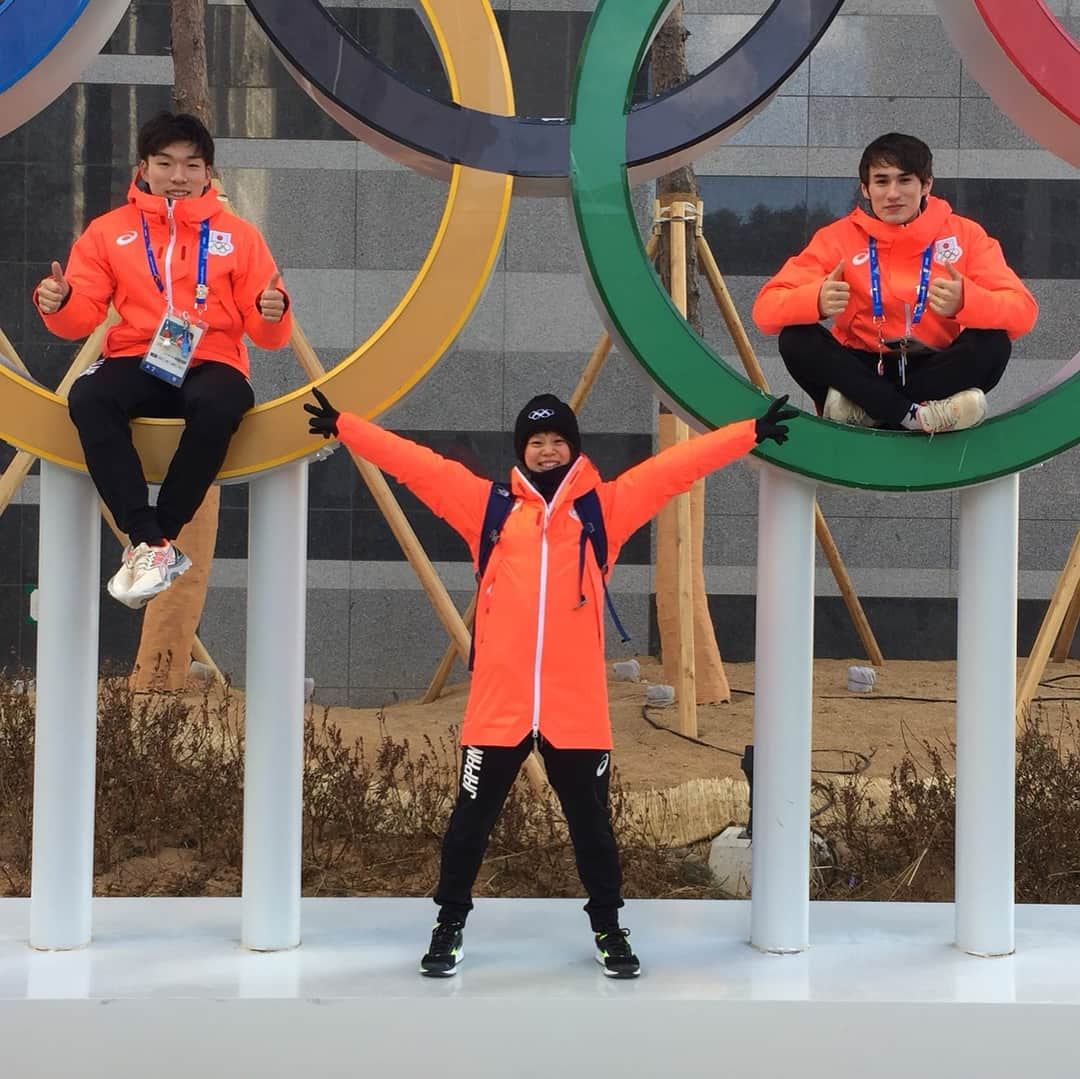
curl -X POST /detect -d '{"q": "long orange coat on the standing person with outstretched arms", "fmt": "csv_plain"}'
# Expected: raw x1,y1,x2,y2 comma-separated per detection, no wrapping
338,413,755,750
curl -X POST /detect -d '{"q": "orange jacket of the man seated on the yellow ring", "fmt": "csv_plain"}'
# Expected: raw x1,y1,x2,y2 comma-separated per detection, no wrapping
33,184,293,375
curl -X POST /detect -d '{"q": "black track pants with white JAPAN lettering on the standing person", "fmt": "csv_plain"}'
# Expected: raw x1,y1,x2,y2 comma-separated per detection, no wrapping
435,734,622,931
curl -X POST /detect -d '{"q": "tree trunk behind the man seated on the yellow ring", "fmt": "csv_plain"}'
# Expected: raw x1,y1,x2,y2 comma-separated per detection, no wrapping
131,0,214,691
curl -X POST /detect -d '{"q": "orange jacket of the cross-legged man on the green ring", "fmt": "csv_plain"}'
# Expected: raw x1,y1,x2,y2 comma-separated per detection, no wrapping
753,197,1039,352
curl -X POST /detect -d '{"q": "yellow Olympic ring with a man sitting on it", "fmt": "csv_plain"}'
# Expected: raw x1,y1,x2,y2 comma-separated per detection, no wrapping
0,0,514,481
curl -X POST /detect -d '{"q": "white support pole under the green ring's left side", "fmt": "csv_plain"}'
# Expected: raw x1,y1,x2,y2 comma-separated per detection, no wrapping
750,464,815,952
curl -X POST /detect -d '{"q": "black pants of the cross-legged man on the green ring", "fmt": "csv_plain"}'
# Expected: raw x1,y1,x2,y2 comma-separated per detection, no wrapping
779,323,1012,427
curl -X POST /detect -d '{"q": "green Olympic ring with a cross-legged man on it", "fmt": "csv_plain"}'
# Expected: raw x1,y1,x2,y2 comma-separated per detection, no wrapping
570,0,1080,490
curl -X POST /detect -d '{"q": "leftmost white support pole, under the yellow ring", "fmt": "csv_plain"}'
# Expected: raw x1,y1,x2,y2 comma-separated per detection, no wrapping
30,460,102,949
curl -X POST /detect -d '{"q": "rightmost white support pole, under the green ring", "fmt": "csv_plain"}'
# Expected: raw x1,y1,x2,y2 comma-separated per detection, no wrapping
956,474,1020,956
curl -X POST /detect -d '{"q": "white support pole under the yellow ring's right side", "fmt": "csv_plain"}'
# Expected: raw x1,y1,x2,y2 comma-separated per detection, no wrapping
241,461,308,952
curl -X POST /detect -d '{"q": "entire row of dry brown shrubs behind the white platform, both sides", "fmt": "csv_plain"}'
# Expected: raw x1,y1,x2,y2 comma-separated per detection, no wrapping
10,674,1080,903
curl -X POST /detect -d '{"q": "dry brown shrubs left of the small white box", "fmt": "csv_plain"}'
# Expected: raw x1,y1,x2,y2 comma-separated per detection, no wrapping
0,676,720,896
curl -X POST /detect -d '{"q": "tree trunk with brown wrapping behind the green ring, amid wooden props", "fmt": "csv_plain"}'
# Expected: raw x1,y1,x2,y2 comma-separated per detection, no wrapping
652,3,731,704
